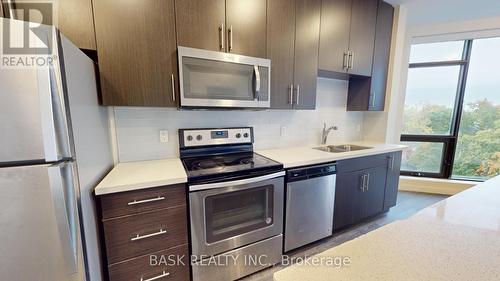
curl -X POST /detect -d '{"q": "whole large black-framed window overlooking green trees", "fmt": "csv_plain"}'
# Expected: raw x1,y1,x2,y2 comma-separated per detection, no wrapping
401,38,500,180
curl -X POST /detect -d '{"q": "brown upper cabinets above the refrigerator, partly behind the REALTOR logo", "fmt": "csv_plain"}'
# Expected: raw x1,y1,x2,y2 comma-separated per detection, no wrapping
0,0,96,51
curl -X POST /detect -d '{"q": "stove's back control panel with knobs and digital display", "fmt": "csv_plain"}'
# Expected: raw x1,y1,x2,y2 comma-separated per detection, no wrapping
179,127,253,147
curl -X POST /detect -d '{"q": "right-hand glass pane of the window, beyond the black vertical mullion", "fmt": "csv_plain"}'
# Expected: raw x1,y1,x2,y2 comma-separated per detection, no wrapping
452,38,500,180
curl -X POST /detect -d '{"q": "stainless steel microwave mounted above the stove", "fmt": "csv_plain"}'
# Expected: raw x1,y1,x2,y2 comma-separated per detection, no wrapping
178,47,271,108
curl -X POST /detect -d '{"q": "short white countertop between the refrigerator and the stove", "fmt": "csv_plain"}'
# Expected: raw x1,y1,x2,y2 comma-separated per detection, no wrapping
95,158,187,195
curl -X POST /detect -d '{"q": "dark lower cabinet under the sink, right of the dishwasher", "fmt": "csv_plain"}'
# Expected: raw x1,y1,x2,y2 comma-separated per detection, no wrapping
333,152,401,230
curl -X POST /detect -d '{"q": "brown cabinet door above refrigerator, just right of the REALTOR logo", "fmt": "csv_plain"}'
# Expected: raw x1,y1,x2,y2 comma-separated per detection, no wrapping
58,0,96,50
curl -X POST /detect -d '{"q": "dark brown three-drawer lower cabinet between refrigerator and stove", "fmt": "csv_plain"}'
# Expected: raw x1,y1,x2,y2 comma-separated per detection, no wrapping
98,184,190,281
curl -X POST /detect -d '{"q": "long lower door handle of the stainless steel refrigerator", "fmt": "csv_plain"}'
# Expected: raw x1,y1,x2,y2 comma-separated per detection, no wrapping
48,162,79,274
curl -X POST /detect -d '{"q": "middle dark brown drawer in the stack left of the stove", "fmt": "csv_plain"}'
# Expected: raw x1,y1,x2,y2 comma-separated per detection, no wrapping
103,205,188,264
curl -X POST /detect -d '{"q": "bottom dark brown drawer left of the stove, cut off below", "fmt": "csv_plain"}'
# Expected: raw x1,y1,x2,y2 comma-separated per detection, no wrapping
108,245,189,281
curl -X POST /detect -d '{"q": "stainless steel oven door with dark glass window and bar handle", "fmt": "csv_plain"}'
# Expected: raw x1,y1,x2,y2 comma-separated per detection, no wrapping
189,172,284,258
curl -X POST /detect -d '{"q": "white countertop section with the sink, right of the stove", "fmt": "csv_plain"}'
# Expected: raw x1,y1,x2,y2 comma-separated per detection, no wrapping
256,142,406,169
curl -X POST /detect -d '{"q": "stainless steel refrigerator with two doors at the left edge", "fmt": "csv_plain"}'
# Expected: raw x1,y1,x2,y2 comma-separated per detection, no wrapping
0,19,113,281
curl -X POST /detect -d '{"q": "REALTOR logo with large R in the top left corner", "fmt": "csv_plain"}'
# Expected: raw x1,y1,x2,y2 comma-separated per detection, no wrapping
1,1,54,67
